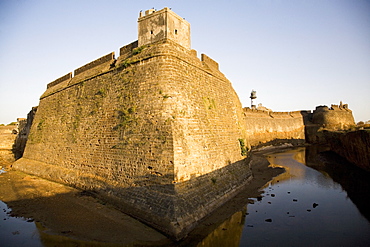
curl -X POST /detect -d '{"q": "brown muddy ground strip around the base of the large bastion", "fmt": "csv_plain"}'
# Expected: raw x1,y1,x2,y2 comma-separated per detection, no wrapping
0,153,283,246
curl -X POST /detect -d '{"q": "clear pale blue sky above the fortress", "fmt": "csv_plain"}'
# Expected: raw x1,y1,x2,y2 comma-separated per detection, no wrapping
0,0,370,124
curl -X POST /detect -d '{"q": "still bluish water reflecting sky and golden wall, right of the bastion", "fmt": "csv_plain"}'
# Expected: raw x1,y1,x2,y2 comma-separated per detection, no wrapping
240,148,370,246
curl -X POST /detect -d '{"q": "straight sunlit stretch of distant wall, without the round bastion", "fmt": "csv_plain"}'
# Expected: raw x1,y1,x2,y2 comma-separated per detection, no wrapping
243,108,305,146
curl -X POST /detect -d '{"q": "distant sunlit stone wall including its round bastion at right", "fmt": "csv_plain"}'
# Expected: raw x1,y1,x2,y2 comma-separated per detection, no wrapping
243,102,355,146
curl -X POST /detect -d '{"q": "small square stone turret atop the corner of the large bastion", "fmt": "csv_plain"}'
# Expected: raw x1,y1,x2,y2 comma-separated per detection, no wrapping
138,8,190,49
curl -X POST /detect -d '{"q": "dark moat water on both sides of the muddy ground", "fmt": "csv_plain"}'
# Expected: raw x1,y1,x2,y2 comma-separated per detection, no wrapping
0,147,370,246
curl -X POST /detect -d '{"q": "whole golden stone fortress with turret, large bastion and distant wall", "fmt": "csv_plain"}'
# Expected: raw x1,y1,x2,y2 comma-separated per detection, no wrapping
13,8,353,239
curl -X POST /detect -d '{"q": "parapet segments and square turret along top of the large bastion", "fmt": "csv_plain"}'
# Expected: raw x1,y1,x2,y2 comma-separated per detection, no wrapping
41,8,194,93
